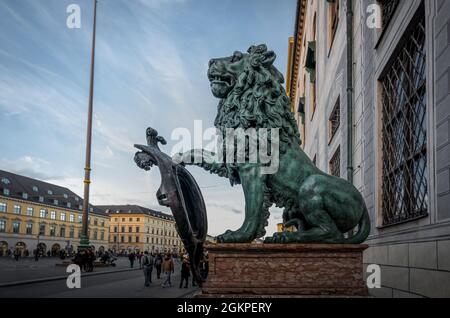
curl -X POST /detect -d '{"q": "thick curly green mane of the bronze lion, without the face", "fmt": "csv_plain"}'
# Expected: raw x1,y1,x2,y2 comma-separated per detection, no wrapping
214,45,301,153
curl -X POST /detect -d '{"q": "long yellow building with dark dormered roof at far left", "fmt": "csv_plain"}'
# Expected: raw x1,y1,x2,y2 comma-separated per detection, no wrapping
0,170,109,255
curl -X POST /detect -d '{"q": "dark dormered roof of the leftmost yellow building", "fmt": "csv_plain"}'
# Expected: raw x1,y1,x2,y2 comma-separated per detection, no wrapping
0,170,108,216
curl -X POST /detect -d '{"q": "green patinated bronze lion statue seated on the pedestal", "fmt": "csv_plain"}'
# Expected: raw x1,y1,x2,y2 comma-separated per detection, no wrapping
184,45,370,244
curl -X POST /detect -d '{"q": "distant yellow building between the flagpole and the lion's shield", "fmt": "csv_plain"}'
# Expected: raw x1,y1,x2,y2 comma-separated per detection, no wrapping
98,205,183,253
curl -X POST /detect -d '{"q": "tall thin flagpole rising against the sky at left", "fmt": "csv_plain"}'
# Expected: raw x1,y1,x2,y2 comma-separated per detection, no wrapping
80,0,97,249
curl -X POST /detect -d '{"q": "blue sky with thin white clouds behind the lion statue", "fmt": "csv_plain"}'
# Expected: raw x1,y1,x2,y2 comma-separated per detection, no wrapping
0,0,296,235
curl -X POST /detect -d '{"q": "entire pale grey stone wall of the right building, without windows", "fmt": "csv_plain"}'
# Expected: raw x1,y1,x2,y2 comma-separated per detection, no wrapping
292,0,450,297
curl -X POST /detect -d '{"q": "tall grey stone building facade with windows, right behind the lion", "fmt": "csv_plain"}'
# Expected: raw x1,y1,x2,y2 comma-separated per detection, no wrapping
287,0,450,297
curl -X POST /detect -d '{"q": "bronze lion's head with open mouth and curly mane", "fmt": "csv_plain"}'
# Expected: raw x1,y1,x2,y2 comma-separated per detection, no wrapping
208,44,300,152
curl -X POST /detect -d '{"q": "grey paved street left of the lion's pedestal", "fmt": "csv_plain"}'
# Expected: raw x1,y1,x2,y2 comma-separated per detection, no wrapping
0,258,197,298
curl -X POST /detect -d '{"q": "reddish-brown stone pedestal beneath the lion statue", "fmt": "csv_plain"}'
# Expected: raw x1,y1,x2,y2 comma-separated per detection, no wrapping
200,244,368,297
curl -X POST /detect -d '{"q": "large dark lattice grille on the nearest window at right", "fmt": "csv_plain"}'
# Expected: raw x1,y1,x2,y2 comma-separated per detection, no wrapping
381,7,428,226
